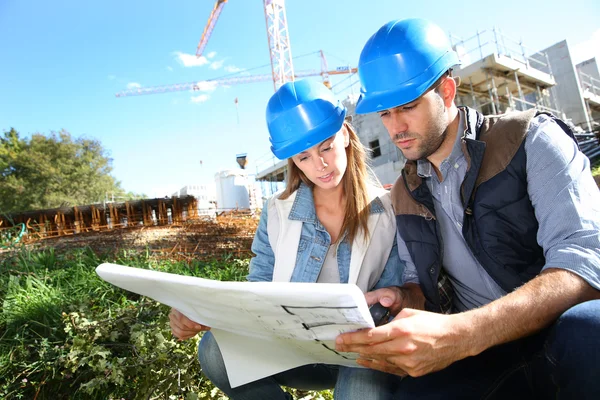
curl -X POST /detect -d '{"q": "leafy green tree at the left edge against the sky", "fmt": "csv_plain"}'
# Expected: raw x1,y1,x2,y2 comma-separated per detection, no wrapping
0,128,138,212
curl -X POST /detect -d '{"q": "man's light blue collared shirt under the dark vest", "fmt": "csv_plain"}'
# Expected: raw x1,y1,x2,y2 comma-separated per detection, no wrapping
398,111,600,311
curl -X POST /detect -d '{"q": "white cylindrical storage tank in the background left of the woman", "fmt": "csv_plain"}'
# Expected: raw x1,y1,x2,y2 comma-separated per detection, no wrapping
215,169,250,211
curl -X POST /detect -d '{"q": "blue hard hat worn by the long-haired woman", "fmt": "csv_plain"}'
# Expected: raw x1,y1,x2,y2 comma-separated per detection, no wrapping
267,80,346,160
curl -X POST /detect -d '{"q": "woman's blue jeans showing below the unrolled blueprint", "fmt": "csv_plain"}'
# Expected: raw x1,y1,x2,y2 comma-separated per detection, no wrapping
198,332,395,400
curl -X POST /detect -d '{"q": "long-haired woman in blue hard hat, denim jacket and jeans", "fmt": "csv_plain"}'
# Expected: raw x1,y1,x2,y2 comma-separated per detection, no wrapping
170,81,403,400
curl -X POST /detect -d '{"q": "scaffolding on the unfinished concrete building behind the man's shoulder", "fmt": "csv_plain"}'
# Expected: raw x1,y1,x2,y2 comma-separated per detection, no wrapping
450,28,563,116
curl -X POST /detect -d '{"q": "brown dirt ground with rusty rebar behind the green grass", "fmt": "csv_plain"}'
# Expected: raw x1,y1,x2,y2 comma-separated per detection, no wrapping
0,212,259,261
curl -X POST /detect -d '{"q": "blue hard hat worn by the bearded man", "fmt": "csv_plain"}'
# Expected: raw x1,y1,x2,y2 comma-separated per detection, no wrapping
356,18,460,114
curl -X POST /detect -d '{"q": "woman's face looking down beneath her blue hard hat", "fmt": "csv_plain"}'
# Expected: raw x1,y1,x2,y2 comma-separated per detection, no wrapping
292,128,350,190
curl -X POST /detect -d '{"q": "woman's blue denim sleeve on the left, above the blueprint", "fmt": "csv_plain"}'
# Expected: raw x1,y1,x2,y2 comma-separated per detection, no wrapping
246,205,275,282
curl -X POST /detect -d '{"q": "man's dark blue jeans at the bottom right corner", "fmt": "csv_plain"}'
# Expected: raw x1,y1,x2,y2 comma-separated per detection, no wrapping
394,300,600,400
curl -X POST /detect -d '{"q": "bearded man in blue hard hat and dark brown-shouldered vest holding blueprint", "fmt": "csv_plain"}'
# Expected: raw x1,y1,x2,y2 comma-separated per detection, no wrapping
337,19,600,399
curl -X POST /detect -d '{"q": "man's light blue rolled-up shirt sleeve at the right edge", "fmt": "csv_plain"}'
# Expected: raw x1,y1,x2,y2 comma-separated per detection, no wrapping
525,115,600,289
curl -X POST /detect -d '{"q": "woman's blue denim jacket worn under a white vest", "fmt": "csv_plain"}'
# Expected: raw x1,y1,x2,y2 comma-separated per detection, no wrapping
248,184,404,290
